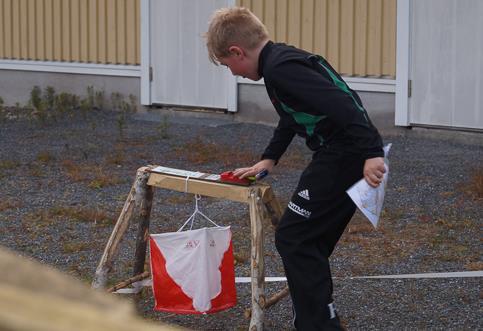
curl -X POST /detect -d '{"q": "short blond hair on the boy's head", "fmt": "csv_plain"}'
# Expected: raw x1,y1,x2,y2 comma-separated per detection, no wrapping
205,7,268,64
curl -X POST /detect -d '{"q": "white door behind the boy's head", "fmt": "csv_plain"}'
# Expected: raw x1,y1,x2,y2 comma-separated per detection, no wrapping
150,0,236,109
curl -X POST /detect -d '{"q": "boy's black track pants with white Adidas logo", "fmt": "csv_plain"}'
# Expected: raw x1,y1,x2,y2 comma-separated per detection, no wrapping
275,150,364,331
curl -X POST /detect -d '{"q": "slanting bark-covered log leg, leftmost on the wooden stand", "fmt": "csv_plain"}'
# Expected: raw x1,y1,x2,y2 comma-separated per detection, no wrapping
91,168,149,288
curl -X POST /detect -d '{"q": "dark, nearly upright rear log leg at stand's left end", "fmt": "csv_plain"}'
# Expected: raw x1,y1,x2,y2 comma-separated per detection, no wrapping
133,173,153,276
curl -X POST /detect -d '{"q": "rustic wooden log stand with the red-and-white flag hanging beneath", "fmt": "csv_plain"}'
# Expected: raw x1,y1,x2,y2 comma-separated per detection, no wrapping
92,166,282,331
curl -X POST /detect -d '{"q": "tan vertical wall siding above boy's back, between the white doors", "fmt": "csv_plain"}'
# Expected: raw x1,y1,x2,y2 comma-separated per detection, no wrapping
237,0,396,78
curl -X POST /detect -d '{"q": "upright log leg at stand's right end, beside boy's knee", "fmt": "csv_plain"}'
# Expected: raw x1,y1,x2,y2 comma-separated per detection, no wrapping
249,189,265,331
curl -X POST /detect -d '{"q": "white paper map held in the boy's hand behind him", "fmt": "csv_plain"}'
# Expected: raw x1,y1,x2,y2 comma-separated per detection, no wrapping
347,144,392,228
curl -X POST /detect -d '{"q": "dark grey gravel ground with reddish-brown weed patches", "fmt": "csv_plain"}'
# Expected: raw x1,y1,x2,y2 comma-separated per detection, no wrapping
0,112,483,330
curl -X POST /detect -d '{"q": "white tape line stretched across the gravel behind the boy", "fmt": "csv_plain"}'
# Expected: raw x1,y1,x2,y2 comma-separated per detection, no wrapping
114,270,483,294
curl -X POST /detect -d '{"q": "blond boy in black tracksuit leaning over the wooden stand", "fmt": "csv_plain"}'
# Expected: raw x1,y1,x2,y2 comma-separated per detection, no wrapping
206,7,385,331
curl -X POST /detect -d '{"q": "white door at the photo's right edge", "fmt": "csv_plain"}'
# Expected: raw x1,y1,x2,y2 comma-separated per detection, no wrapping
409,0,483,129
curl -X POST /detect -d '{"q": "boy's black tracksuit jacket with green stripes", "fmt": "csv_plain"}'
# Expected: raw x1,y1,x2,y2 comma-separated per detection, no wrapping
258,41,384,162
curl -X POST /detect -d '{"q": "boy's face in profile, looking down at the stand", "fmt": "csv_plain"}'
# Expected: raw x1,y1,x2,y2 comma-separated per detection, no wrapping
219,46,260,80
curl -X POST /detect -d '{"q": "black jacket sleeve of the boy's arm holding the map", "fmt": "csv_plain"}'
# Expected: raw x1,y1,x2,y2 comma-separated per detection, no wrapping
270,59,384,159
